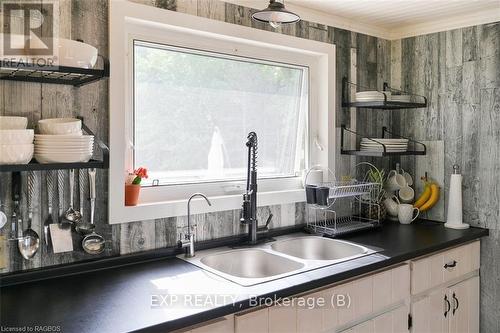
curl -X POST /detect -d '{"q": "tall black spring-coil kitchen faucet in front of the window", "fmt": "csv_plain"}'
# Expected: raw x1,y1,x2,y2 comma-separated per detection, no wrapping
240,132,273,245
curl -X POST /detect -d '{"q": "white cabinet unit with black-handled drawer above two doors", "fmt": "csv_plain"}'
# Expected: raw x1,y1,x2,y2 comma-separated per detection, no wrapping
411,241,480,333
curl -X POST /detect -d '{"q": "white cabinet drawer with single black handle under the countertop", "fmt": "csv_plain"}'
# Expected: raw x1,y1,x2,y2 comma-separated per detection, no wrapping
411,241,480,295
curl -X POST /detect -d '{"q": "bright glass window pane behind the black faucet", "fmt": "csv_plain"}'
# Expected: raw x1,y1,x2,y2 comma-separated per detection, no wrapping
133,41,309,185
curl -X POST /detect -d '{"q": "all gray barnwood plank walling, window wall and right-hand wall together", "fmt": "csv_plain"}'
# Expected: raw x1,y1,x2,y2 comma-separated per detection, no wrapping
0,0,500,332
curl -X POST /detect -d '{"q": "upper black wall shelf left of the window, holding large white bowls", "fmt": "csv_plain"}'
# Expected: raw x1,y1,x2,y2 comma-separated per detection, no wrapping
0,56,109,87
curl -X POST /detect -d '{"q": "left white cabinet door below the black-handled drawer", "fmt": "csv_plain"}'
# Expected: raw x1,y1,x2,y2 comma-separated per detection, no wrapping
411,288,451,333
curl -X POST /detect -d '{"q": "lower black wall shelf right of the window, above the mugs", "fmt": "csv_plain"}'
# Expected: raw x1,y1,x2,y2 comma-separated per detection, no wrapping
340,125,427,157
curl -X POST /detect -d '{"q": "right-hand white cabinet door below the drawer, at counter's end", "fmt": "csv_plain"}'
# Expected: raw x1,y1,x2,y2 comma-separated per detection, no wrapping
448,276,479,333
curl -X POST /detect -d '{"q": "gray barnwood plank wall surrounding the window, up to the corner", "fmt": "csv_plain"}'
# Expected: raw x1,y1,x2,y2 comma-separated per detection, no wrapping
0,0,392,273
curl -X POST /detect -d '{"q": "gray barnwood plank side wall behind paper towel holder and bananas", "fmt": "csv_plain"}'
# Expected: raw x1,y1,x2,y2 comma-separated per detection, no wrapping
391,22,500,332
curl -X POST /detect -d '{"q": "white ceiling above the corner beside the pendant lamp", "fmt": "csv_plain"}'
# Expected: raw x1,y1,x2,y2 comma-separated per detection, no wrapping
226,0,500,39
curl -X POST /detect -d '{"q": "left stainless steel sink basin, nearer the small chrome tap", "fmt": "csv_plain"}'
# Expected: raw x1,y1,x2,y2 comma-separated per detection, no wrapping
200,249,304,278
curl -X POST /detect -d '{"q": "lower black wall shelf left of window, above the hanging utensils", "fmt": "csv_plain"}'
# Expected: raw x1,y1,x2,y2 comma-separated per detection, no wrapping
0,117,109,172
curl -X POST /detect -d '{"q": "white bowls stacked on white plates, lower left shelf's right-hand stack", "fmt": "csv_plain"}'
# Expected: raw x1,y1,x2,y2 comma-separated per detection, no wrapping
35,118,94,163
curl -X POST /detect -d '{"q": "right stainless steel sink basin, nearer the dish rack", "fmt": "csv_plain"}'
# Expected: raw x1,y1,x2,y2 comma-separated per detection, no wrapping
271,236,368,260
